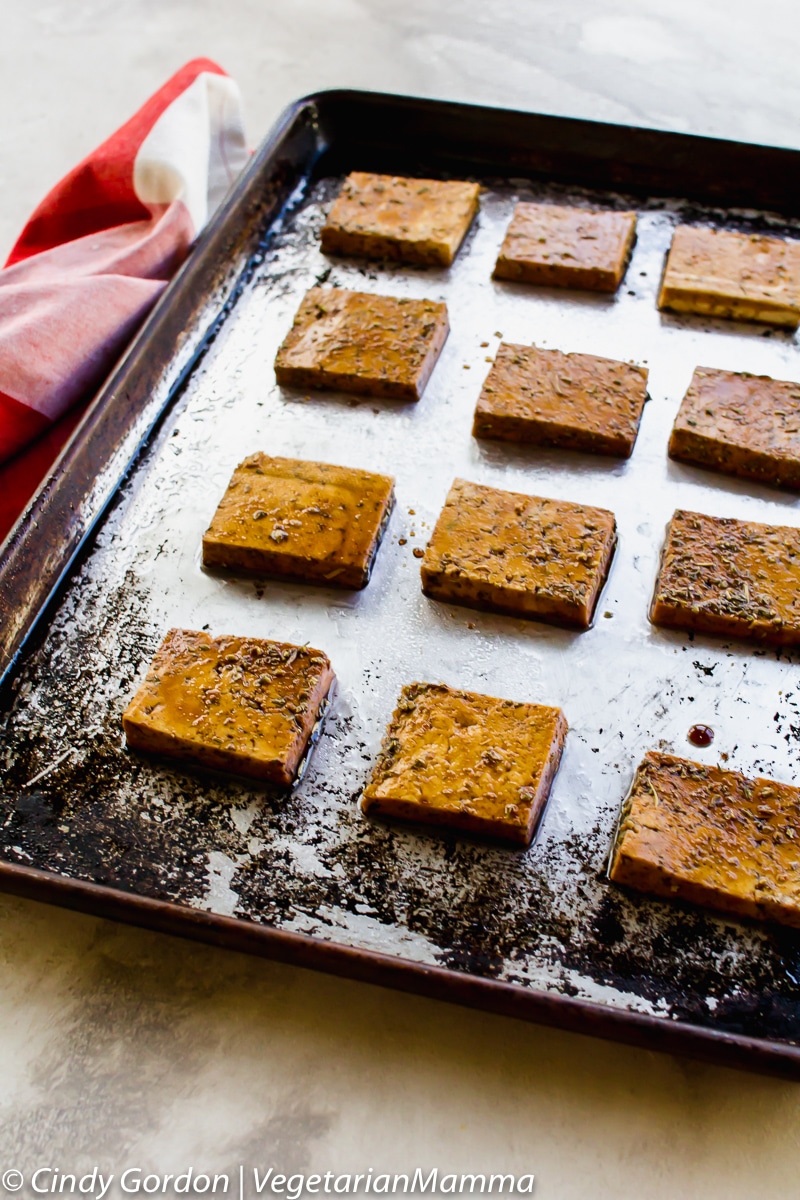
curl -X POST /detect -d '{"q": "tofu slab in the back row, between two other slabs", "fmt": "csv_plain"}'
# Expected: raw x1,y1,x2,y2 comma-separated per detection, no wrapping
494,203,636,292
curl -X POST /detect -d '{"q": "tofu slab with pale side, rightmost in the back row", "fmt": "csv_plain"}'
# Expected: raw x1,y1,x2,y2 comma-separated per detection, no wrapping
658,226,800,329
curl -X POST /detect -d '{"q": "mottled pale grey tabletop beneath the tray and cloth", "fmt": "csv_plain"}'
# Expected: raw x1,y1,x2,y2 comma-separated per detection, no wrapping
0,0,800,1200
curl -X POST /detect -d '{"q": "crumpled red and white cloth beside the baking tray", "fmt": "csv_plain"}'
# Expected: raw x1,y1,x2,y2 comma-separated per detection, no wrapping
0,59,248,540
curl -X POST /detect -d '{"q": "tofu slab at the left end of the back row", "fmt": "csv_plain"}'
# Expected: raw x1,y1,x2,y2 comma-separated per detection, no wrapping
323,170,481,266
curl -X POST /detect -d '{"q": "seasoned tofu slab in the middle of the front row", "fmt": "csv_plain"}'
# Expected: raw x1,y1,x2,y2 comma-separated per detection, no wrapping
361,683,567,846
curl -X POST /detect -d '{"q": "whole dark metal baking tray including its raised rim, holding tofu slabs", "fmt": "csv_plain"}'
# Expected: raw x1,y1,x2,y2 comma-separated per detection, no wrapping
0,91,800,1078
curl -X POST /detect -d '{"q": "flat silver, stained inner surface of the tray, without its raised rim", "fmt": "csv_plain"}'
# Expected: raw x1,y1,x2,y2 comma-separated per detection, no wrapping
0,171,800,1044
